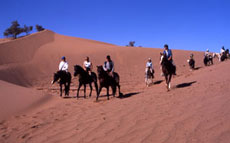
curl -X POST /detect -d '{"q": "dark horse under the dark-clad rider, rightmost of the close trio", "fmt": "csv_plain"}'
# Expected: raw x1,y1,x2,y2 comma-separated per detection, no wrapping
97,66,122,100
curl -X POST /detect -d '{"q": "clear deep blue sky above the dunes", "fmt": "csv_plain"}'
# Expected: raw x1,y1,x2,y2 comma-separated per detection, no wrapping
0,0,230,51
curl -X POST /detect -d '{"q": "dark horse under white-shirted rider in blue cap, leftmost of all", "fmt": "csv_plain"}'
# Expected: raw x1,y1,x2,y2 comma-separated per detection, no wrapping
52,71,72,96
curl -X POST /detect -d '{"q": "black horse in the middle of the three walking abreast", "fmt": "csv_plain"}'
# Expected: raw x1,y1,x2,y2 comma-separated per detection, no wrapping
74,65,98,98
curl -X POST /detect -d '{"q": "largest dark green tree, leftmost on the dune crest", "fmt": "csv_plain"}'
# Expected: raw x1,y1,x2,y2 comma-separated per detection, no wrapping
4,21,23,39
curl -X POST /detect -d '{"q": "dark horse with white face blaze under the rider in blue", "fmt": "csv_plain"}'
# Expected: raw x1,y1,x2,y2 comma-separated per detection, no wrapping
161,54,176,91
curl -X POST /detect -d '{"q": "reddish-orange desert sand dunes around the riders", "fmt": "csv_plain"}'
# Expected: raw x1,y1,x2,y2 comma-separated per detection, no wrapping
0,30,230,143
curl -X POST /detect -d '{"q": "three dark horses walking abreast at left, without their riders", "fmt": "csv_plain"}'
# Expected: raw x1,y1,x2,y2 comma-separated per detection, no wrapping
52,65,122,101
